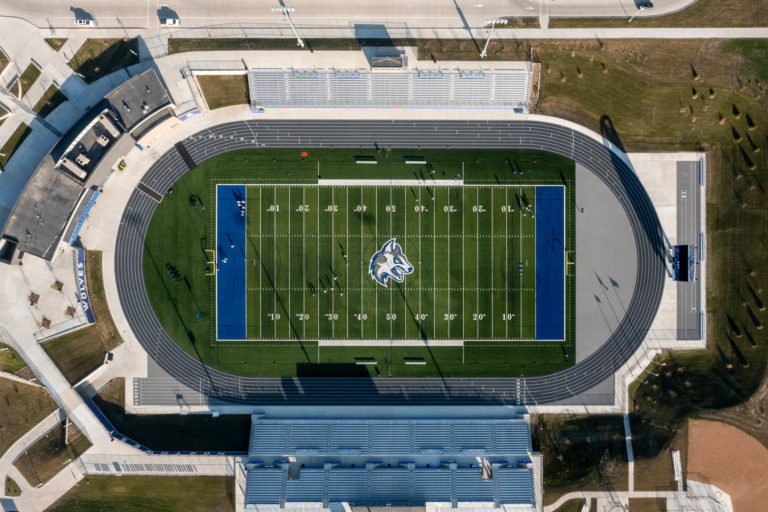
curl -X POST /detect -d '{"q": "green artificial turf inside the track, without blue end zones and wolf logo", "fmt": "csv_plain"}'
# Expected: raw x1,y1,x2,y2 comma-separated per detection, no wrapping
144,149,575,377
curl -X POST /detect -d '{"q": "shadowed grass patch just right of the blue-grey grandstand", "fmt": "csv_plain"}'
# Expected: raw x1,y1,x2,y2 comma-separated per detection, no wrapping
532,415,628,504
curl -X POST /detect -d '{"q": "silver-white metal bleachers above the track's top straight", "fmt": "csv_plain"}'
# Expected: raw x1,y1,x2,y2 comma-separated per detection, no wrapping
248,67,531,112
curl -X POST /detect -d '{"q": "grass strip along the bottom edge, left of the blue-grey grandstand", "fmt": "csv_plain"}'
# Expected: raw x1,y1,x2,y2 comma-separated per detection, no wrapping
47,476,235,512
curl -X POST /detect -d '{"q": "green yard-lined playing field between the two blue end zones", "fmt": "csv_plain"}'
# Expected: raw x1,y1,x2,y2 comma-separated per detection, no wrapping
218,180,558,343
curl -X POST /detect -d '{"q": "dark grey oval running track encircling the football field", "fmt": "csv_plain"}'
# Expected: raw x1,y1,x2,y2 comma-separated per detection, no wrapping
115,120,665,405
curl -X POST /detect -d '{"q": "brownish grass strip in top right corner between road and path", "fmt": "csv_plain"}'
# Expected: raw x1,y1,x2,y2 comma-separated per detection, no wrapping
549,0,768,28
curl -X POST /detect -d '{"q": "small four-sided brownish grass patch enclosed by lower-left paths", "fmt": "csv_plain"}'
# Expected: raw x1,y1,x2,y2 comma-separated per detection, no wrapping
13,423,91,487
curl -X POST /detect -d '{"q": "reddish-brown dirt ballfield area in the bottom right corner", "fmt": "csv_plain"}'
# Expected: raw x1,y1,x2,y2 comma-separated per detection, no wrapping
688,420,768,511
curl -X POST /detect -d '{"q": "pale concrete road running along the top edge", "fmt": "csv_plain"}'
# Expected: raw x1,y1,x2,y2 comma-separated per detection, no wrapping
0,0,694,28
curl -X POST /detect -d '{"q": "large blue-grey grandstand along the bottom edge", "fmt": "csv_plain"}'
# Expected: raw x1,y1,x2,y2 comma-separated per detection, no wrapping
245,415,535,511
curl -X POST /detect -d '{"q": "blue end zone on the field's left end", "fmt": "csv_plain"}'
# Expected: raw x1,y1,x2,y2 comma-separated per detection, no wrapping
216,185,246,340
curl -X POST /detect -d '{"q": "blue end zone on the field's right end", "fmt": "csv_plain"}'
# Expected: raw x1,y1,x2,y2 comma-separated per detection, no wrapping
536,187,565,340
